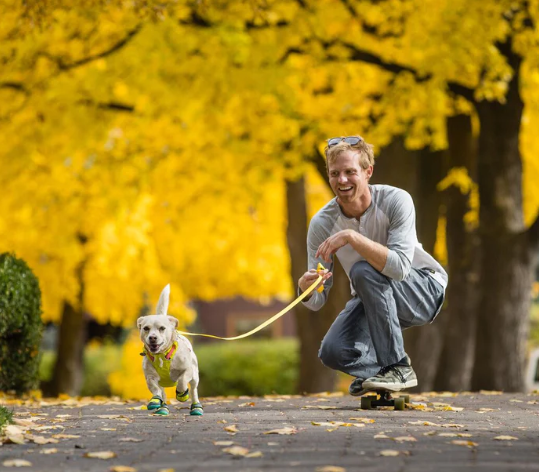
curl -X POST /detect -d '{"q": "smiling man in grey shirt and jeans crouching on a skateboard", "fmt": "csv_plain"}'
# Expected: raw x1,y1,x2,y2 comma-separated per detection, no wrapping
298,136,447,396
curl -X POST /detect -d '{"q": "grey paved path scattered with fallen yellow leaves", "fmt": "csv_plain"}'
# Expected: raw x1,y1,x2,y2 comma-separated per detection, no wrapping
0,394,539,472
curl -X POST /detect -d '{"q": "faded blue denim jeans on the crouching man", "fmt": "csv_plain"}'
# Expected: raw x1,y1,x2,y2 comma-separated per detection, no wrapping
318,261,444,379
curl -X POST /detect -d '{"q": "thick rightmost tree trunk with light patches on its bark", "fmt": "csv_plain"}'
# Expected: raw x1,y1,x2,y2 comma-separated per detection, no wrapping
472,40,533,392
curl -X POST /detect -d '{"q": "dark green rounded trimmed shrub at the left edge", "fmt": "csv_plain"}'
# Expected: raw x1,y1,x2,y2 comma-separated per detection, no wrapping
0,253,43,394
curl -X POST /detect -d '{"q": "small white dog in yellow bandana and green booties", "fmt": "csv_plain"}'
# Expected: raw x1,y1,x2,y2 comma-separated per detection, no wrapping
137,285,204,416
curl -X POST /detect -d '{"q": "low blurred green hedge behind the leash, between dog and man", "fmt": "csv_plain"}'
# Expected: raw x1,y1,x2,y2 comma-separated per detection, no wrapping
195,339,299,397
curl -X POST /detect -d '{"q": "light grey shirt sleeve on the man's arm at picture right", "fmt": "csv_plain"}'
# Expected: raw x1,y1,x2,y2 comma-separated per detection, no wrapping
382,190,417,282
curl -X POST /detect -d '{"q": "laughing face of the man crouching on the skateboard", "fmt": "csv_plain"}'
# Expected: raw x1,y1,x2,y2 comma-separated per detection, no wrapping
328,151,372,203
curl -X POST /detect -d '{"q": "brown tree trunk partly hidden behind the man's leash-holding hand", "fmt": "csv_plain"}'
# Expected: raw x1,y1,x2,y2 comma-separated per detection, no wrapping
286,178,350,393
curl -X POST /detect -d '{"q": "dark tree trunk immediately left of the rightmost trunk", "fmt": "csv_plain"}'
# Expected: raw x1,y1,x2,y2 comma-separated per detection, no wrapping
434,115,479,391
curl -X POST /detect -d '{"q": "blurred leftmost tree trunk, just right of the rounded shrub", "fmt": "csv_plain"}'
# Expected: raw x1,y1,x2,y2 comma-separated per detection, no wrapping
47,234,87,396
